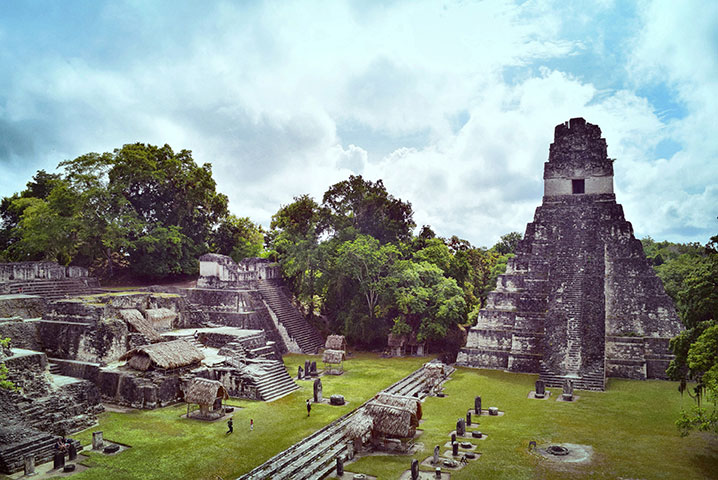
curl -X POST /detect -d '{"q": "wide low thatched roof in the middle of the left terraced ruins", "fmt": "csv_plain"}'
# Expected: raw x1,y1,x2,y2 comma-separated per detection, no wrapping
120,340,204,371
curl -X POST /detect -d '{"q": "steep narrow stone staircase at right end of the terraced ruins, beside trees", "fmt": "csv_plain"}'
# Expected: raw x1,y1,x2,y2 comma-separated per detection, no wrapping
257,280,324,354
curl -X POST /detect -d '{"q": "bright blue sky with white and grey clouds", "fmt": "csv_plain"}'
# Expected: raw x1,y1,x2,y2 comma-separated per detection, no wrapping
0,0,718,247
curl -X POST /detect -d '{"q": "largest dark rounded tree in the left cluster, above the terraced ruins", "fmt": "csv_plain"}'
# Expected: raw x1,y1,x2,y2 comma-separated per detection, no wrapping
60,143,228,278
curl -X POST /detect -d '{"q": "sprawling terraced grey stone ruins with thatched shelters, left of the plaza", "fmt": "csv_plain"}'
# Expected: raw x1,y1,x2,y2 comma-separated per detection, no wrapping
0,255,324,473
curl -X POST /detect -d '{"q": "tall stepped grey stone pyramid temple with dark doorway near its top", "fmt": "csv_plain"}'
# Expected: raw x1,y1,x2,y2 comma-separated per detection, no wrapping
457,118,681,390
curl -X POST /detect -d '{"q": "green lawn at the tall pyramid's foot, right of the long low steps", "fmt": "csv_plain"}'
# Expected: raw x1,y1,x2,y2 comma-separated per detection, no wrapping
338,368,718,480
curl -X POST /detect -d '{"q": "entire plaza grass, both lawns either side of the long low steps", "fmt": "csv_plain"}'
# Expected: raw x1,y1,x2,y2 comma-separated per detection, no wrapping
25,354,718,480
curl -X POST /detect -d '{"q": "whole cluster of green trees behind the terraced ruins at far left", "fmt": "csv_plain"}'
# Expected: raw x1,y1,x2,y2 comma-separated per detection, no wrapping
0,143,229,278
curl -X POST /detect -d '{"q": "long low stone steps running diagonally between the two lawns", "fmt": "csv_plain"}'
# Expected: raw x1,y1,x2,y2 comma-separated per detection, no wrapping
240,367,454,480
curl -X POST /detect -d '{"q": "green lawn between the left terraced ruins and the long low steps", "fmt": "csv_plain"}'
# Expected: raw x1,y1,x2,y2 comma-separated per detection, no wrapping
52,353,429,480
